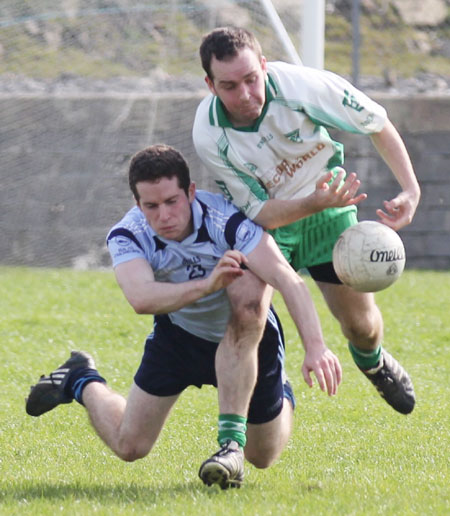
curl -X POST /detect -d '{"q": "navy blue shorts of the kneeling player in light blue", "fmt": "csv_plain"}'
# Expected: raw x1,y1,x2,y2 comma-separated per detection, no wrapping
134,309,284,424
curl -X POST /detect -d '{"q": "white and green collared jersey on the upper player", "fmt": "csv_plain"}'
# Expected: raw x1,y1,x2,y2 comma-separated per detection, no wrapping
193,62,386,218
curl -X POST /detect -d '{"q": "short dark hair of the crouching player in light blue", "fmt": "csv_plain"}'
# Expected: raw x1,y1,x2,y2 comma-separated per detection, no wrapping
128,143,191,201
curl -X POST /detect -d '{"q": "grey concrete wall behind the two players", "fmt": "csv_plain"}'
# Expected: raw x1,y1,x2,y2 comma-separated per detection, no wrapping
0,94,450,269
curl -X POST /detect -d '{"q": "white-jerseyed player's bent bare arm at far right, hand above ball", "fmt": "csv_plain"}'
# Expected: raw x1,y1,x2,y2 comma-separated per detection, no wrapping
371,120,420,230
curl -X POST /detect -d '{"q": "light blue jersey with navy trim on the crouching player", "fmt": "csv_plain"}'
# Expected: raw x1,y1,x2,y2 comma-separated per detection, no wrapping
107,190,263,342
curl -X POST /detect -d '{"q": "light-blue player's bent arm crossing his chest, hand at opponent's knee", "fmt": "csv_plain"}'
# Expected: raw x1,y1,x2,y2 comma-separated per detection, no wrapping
114,251,245,315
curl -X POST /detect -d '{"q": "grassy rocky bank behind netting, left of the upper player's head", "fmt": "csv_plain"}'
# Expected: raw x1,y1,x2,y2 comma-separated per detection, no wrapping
0,5,201,79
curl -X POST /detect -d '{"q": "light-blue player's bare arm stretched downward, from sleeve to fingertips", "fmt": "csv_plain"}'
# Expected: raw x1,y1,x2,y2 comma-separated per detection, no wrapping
247,233,342,396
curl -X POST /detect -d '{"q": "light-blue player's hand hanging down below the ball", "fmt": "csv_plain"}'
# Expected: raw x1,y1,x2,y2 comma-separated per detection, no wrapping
302,346,342,396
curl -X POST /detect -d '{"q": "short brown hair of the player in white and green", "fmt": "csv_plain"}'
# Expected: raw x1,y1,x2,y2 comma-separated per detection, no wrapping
200,27,262,80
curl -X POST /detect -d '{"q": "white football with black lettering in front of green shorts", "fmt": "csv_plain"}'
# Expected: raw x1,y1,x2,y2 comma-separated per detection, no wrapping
333,220,406,292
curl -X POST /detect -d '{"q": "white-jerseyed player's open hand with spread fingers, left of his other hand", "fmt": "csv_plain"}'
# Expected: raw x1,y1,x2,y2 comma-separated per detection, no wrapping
312,168,367,211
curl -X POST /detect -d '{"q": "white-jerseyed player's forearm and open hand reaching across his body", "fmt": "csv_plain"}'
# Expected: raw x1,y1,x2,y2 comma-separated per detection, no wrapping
254,169,367,229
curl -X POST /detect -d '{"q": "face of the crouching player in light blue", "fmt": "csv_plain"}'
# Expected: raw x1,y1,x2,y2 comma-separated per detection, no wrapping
136,177,195,242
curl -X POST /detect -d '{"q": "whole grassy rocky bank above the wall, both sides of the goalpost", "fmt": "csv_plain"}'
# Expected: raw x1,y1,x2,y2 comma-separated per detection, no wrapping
0,0,450,79
